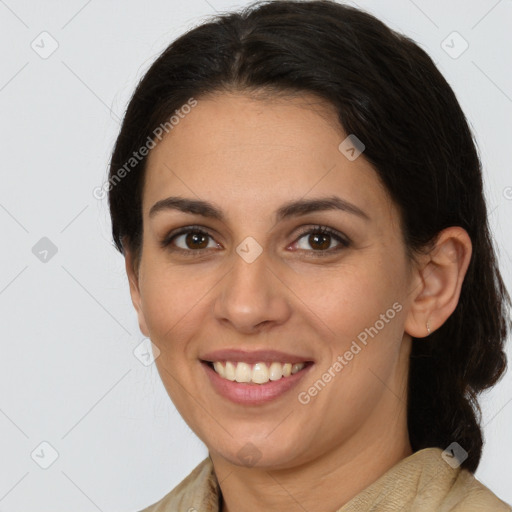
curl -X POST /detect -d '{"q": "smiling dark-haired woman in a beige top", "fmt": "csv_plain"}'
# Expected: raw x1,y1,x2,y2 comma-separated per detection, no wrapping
109,1,510,512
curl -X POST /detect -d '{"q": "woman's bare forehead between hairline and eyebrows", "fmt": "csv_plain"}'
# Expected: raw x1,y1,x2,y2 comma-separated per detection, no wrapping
143,94,386,222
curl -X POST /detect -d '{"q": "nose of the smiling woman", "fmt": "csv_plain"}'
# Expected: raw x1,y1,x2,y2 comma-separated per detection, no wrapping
213,251,291,334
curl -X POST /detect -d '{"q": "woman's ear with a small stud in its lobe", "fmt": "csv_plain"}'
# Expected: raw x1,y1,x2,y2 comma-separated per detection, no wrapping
404,226,472,338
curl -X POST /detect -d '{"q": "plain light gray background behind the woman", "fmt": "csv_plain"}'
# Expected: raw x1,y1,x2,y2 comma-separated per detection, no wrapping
0,0,512,512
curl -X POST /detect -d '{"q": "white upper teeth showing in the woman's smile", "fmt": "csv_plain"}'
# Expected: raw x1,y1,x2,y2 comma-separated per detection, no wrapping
213,361,305,384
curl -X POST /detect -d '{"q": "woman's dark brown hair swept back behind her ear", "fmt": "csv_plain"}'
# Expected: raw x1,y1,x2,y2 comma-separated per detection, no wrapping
109,0,510,472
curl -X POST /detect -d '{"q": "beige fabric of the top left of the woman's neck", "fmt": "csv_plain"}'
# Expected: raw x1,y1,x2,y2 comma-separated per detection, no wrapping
140,457,219,512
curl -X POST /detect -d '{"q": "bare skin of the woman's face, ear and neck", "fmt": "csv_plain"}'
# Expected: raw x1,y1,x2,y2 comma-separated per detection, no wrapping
125,93,471,512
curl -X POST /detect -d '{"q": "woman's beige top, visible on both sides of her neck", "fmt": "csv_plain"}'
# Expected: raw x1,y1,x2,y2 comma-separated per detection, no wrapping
141,448,512,512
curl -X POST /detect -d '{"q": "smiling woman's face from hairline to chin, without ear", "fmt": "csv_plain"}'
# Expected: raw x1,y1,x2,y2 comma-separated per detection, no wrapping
127,94,412,468
